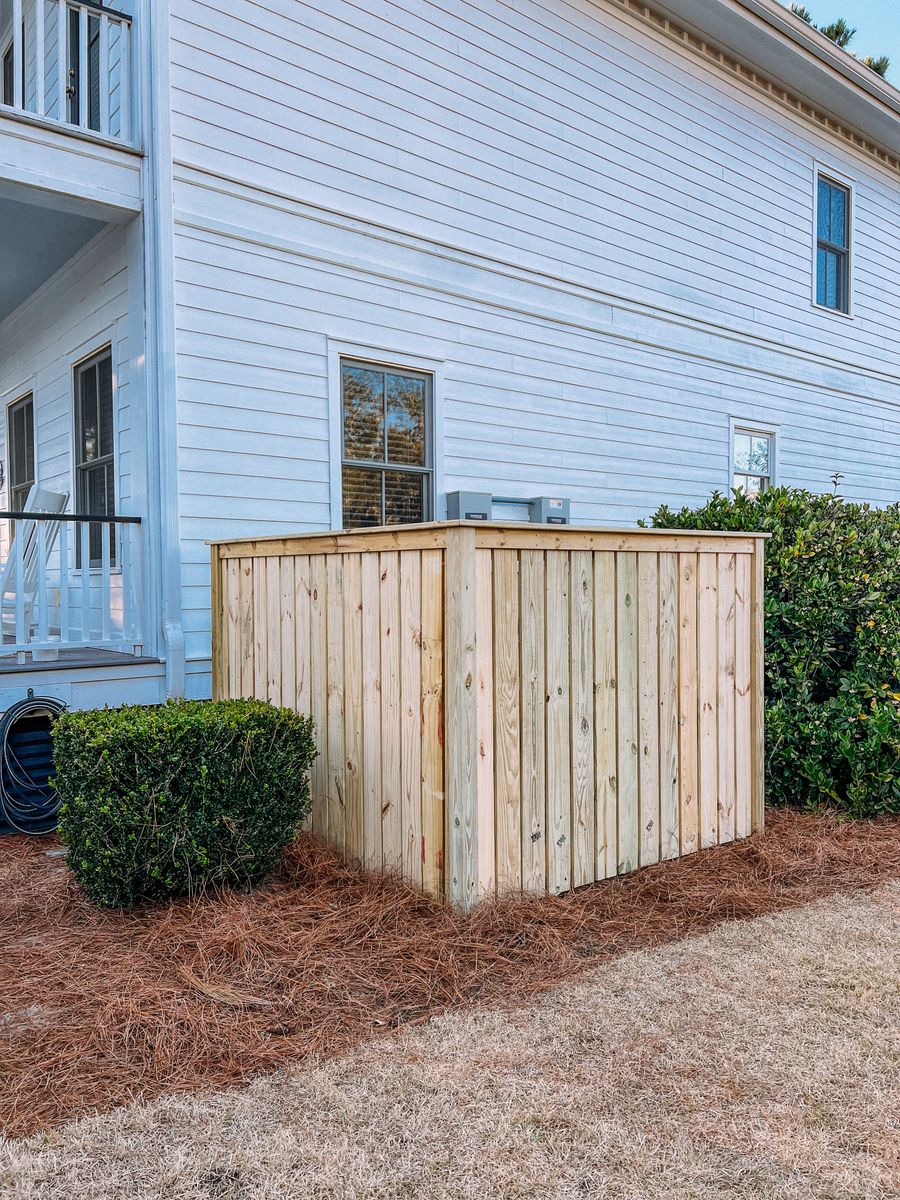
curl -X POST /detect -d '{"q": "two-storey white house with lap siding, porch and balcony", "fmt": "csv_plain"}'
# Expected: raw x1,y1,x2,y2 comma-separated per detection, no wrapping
0,0,900,708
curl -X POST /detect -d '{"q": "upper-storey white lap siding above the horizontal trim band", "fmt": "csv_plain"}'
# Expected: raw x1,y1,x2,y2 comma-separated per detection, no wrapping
173,0,900,368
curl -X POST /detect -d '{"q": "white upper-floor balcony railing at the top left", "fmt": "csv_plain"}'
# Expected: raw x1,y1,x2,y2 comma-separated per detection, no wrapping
0,0,133,143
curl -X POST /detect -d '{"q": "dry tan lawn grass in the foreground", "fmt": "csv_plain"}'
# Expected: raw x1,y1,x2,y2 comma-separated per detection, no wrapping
0,884,900,1200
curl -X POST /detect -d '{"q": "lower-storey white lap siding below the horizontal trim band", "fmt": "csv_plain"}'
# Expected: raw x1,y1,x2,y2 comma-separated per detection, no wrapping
176,199,900,658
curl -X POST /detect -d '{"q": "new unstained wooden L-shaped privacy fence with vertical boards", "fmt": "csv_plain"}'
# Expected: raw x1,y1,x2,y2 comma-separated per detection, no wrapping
212,522,764,907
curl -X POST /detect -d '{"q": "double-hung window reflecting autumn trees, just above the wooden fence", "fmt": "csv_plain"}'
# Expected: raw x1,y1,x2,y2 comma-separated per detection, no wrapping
341,360,433,529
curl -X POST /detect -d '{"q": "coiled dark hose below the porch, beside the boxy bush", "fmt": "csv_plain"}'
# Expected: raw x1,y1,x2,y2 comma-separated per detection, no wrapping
0,696,66,836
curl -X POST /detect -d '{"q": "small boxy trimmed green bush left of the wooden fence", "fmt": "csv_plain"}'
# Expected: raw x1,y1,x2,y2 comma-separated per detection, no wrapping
53,700,316,907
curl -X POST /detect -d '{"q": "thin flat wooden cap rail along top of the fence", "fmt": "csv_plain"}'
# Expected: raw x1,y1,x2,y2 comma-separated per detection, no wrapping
208,521,772,547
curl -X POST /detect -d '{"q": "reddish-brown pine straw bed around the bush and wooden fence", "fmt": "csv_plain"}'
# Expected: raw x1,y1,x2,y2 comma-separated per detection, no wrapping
0,811,900,1136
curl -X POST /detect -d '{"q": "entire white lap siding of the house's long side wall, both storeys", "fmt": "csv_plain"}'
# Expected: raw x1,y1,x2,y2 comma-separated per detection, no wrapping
172,0,900,689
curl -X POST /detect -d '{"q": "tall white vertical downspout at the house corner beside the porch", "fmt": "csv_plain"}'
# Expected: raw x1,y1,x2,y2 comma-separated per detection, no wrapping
140,0,185,697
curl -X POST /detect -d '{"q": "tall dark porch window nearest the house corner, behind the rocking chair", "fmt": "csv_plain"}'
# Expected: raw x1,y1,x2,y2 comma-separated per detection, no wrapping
74,349,115,566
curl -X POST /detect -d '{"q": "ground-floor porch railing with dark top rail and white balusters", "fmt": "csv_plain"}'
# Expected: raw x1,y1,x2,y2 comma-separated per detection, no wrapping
0,512,144,660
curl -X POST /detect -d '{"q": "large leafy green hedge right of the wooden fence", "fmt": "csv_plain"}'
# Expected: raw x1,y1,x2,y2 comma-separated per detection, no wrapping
650,488,900,816
